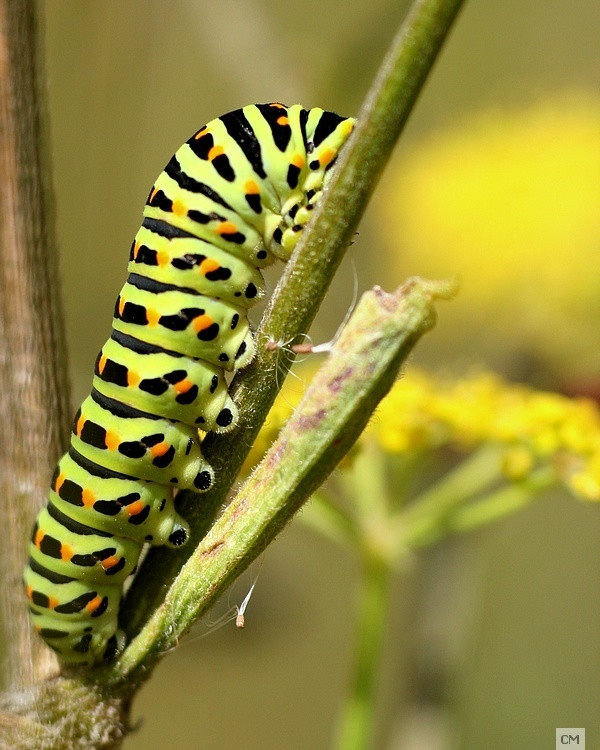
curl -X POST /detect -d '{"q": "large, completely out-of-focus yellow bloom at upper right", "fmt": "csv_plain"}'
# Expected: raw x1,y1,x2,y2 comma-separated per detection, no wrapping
376,92,600,376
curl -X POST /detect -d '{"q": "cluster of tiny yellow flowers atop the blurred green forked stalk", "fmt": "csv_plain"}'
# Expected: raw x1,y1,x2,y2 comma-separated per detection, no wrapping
248,369,600,500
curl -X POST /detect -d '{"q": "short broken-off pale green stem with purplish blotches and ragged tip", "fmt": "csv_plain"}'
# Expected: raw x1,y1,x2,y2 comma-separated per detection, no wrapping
105,279,450,683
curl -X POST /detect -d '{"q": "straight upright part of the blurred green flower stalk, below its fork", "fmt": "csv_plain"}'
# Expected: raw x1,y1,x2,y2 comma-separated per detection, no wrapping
334,554,392,750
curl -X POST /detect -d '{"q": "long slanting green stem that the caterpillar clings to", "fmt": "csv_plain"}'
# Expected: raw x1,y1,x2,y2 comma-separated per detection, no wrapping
122,0,462,652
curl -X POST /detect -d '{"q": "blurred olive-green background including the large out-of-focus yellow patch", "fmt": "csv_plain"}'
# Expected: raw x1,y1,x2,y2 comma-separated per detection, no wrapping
40,0,600,750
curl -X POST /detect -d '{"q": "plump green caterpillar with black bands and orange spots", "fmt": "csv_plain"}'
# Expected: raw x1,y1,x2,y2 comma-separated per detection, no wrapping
24,103,354,665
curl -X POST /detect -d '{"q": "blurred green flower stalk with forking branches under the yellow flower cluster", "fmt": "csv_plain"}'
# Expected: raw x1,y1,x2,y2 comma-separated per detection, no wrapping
334,456,556,750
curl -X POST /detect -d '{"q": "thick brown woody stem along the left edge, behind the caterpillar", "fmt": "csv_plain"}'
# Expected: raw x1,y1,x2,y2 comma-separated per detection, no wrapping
0,0,69,690
